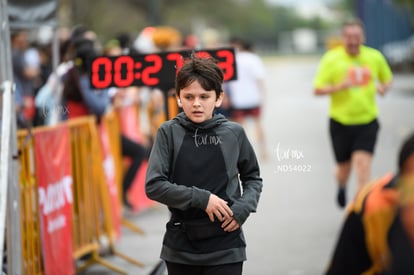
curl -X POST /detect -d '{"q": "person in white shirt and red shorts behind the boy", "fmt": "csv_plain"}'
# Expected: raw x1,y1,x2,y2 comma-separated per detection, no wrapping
224,37,267,159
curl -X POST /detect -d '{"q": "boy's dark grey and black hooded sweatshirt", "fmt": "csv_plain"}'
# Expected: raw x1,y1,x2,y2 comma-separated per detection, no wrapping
146,113,262,265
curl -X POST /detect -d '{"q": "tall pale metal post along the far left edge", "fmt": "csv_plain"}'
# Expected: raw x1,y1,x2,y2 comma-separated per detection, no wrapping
0,0,22,275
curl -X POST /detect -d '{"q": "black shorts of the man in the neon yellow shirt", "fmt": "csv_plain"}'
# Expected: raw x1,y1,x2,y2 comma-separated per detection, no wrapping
329,118,380,163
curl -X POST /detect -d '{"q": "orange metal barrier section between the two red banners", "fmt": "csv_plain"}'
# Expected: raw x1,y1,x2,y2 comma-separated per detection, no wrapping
67,116,127,274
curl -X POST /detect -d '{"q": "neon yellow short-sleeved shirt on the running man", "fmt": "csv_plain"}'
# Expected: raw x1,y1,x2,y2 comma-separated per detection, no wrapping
314,46,392,125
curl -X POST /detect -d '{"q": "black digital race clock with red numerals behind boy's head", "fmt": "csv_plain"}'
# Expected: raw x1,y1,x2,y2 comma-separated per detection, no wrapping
90,48,237,89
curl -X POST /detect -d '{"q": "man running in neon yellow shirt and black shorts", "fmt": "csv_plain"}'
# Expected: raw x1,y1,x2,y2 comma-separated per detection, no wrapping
314,20,392,207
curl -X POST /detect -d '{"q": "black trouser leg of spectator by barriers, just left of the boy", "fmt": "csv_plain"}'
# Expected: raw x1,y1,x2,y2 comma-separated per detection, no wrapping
121,135,148,195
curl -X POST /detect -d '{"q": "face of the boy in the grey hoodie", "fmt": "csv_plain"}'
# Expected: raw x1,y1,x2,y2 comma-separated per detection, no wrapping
177,81,223,123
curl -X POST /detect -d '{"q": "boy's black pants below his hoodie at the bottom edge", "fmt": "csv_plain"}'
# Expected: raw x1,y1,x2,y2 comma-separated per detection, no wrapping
166,262,243,275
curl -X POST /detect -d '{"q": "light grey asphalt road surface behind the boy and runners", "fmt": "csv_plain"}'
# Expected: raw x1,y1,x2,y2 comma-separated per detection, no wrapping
84,57,414,275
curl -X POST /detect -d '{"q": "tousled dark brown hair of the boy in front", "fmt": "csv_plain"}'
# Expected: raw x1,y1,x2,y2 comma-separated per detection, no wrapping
175,55,224,98
